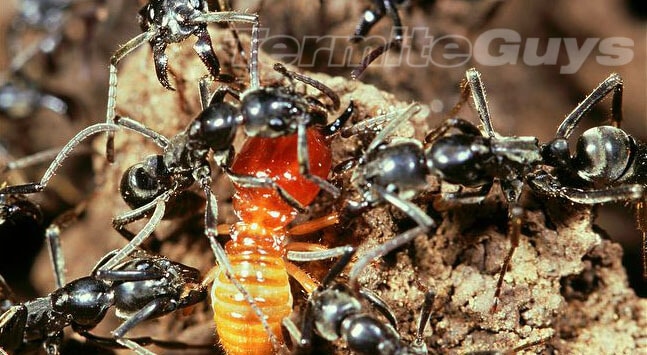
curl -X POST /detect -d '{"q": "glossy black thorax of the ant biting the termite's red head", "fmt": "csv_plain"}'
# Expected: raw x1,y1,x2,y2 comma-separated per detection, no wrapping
194,102,242,152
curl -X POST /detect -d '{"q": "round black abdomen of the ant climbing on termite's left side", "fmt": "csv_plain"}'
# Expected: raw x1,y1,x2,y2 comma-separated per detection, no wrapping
119,155,171,208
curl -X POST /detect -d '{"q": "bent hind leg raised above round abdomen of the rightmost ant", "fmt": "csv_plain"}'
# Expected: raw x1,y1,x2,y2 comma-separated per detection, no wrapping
555,73,624,139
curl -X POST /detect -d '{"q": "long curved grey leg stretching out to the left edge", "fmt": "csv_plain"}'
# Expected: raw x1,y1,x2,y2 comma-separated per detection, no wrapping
0,123,119,194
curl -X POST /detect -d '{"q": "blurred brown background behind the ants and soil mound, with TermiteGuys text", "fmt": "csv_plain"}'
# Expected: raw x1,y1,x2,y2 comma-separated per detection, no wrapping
0,0,647,350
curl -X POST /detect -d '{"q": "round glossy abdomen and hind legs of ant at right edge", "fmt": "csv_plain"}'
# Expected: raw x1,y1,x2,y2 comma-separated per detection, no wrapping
528,73,647,279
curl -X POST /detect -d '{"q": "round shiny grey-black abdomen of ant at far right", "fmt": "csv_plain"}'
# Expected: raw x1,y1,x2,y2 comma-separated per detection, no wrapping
573,126,634,185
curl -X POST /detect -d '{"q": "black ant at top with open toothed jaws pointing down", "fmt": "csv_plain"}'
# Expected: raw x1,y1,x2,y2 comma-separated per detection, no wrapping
106,0,259,162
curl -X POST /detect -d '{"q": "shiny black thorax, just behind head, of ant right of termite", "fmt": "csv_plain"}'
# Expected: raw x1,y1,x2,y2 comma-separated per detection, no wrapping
425,134,494,187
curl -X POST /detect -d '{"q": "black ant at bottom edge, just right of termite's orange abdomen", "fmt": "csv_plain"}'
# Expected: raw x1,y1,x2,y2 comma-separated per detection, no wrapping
284,247,435,355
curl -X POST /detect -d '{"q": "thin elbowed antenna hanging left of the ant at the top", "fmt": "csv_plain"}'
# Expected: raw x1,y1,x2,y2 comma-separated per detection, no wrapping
106,31,155,163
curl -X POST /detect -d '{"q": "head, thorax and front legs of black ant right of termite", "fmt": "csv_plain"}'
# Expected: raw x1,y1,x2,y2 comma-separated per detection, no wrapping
346,69,543,309
